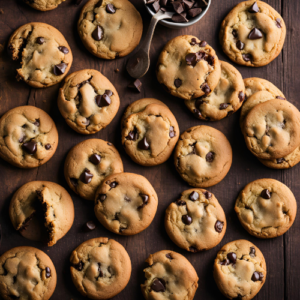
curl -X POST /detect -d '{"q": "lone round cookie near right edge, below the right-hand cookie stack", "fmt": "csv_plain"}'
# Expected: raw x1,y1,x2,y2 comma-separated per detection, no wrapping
234,178,297,239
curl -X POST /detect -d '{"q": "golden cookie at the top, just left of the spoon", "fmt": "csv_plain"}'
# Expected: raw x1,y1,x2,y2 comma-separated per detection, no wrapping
77,0,143,59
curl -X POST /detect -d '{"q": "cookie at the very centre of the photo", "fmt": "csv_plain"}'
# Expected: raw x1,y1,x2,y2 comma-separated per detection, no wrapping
122,98,179,166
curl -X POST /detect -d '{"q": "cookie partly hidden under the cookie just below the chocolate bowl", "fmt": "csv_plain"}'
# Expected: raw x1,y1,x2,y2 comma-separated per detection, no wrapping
184,61,245,121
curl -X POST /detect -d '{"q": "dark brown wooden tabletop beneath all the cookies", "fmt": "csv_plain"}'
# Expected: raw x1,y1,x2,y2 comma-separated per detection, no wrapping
0,0,300,300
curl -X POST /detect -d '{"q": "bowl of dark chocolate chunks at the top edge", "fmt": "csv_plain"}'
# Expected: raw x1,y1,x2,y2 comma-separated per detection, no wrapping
144,0,211,29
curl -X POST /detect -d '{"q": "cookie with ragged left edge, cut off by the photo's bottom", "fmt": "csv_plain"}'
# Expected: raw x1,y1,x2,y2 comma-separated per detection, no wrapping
141,250,199,300
